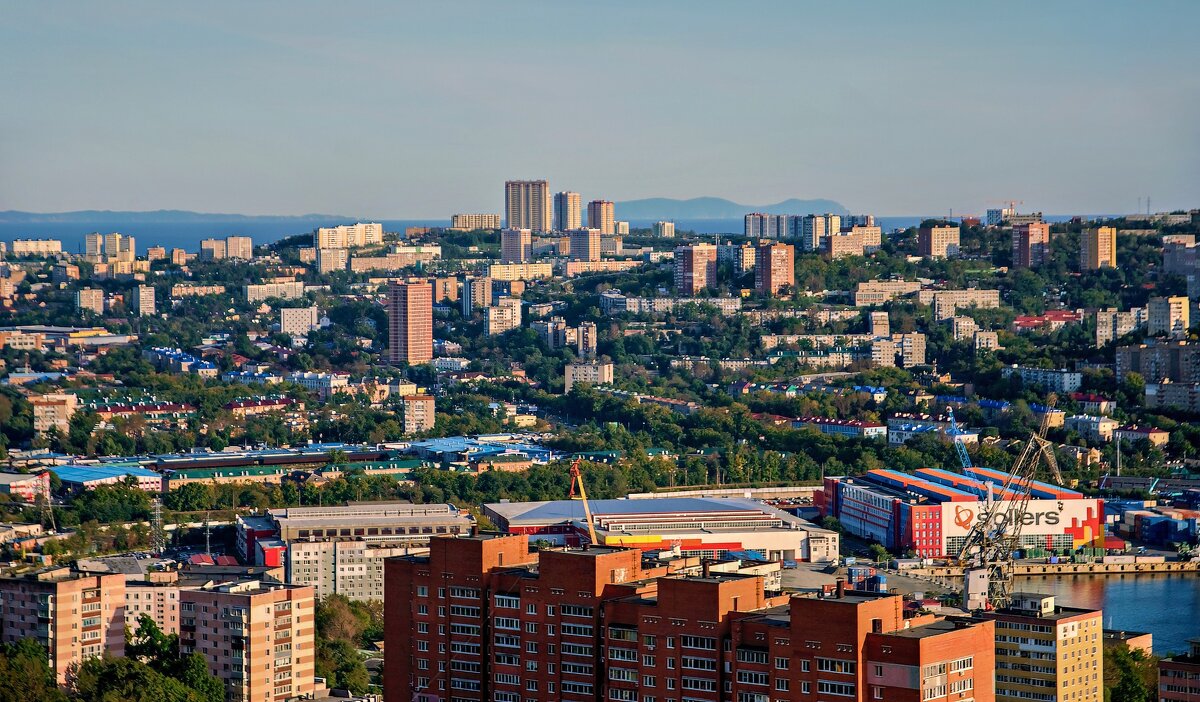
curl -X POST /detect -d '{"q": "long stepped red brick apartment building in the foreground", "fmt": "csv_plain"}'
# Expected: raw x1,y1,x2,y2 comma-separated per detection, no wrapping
384,534,995,702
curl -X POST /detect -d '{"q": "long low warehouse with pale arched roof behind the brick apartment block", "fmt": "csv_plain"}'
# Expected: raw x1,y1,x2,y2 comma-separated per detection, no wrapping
484,497,839,563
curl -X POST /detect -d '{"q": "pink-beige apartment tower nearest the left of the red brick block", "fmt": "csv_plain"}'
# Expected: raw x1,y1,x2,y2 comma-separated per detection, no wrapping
179,581,317,702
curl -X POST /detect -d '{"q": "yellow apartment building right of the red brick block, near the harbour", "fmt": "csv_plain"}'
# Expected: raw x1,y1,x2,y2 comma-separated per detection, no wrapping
982,593,1104,702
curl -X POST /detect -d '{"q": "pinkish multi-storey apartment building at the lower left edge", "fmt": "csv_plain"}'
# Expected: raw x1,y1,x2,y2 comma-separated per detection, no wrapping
0,568,125,685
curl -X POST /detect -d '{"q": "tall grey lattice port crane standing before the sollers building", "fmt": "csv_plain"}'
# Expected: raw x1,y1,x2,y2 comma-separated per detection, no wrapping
950,396,1063,608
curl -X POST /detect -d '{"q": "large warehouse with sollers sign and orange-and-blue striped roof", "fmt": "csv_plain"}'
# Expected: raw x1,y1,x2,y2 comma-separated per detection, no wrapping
815,467,1104,558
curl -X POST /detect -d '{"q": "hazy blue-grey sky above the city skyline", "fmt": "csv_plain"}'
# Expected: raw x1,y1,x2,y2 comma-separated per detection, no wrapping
0,0,1200,217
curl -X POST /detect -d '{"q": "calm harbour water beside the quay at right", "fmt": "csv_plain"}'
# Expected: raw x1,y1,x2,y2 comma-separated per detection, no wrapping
1015,574,1200,655
